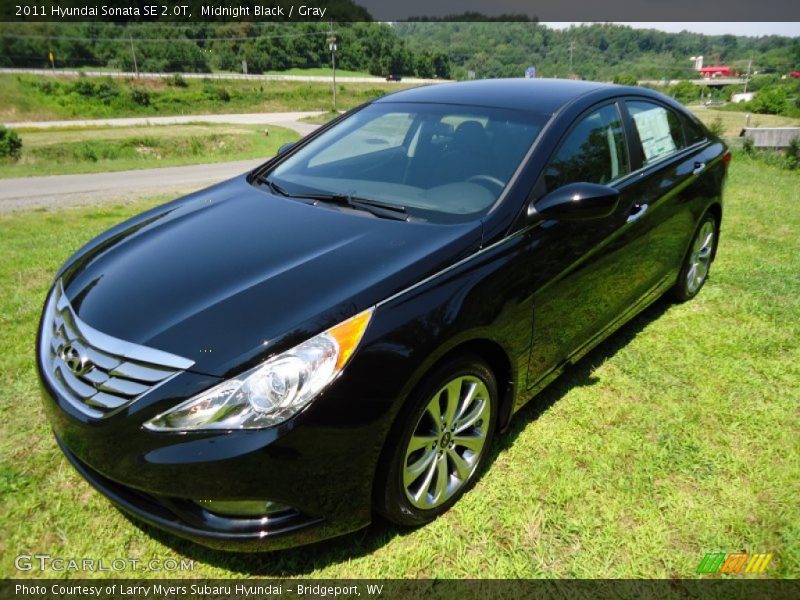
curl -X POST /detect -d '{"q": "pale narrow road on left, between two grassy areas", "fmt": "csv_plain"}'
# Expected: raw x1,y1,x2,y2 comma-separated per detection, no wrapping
4,111,322,135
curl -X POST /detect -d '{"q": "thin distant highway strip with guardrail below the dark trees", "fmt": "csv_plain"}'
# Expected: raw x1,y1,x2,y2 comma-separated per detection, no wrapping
0,68,448,84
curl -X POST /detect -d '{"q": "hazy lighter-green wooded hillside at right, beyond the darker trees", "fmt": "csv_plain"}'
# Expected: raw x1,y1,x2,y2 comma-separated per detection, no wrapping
394,22,800,80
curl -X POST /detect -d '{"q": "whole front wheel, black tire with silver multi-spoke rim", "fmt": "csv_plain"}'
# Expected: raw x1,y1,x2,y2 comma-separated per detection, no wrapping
375,355,499,526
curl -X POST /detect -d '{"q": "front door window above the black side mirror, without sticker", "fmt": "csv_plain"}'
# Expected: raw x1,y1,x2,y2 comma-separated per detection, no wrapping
545,104,630,191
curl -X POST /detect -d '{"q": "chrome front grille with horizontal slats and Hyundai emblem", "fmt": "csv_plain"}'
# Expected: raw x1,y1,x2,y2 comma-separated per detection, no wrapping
40,280,194,418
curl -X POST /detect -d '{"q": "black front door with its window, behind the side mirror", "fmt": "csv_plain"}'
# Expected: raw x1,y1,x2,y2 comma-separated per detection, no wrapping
528,101,664,387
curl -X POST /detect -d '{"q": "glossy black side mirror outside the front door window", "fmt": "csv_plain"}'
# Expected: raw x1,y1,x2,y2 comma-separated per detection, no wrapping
528,182,619,221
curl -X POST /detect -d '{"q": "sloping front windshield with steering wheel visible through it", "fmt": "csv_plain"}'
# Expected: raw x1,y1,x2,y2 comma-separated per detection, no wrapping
265,102,546,222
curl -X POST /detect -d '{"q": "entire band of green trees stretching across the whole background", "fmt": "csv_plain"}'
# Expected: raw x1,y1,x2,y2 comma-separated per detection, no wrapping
0,21,800,80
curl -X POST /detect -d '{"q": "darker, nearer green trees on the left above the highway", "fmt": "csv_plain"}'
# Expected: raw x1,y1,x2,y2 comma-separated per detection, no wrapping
0,21,451,78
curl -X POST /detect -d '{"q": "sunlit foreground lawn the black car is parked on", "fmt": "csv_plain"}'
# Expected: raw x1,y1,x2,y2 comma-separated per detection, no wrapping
0,156,800,578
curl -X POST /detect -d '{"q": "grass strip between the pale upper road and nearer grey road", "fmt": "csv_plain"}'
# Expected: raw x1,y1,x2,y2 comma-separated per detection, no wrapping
0,123,300,178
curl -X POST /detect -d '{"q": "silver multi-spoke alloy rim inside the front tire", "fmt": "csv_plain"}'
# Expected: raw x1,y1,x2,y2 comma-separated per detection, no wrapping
403,375,492,509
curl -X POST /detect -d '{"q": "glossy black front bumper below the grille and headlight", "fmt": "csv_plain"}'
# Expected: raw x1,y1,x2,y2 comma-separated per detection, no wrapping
40,360,387,552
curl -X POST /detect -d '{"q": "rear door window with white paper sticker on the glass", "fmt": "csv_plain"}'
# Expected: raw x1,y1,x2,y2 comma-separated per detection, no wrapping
627,100,686,165
